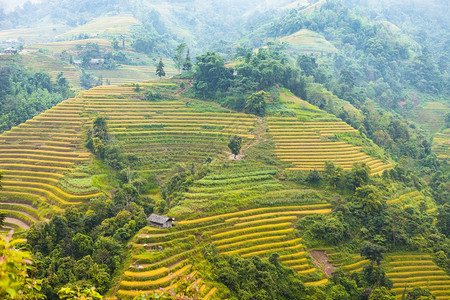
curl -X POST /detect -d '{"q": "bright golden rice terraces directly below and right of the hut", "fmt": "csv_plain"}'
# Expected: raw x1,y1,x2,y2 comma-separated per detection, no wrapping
117,204,331,298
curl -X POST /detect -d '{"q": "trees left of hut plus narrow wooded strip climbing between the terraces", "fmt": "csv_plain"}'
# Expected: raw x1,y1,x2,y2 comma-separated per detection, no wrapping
0,117,156,299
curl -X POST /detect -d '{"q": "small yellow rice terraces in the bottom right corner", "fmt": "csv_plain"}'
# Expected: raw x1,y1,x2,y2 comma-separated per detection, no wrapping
386,253,450,299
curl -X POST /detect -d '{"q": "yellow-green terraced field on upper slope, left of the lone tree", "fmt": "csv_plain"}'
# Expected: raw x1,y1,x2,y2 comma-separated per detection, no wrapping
78,82,256,168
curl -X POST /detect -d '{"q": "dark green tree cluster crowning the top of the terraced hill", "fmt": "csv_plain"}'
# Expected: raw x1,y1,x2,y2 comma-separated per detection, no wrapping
194,48,305,115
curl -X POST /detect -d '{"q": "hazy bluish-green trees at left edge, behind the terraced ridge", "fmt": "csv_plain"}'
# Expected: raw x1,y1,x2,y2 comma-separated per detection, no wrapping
0,65,73,133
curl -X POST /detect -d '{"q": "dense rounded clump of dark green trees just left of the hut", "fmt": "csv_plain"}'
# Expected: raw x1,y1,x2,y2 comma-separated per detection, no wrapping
27,195,146,299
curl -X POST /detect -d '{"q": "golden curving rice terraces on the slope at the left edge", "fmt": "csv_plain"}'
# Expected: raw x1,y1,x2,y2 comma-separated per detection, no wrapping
0,99,99,229
